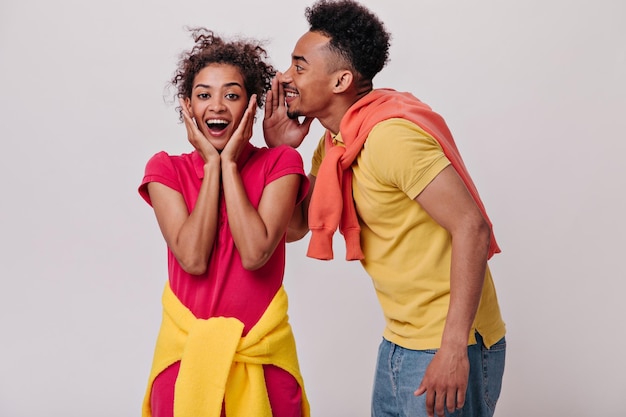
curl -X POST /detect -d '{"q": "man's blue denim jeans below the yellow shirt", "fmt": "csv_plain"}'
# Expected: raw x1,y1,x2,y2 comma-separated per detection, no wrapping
372,333,506,417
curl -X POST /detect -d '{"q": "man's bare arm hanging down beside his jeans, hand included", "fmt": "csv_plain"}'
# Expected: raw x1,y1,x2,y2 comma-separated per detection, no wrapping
415,166,491,417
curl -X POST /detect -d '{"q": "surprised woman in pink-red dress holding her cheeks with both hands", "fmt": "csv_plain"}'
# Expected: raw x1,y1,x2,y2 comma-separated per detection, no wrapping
139,28,309,417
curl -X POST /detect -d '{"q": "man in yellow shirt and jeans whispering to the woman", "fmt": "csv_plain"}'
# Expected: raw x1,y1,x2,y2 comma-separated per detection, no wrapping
264,0,506,417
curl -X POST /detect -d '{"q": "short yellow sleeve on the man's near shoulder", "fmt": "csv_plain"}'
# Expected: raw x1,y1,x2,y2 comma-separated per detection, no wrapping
363,119,450,200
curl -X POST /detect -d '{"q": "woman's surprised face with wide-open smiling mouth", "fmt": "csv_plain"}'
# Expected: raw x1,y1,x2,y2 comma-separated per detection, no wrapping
185,64,249,151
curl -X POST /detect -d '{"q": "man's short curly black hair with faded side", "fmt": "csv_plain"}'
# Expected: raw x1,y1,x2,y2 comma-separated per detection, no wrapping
305,0,391,80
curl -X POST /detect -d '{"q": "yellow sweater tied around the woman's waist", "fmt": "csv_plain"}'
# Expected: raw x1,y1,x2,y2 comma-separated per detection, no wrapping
142,283,310,417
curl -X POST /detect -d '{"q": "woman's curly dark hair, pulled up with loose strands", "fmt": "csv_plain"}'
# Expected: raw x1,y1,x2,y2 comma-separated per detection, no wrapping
171,28,276,120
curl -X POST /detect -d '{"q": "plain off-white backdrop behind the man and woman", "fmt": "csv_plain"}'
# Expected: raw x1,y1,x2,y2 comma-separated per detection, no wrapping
0,0,626,417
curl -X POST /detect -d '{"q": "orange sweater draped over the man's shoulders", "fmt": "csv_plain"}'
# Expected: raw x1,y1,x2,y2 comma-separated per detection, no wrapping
307,89,500,260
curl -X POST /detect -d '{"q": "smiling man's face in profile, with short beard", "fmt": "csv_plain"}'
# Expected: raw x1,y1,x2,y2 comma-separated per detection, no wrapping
279,32,335,119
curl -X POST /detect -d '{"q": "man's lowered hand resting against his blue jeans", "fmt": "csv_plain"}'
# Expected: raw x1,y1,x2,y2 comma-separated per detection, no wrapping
415,346,469,417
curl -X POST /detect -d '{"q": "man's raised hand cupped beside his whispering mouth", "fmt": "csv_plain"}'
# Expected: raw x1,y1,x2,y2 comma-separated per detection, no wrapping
263,73,313,148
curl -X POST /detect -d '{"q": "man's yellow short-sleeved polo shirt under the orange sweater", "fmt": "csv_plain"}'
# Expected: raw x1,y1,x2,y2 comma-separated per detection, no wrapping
311,119,505,350
